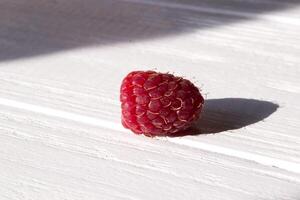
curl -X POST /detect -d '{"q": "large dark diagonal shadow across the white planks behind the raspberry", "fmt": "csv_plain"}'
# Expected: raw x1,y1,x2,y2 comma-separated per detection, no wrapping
0,0,300,61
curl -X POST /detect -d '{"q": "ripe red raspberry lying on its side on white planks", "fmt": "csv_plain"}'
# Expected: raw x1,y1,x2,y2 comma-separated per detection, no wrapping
120,71,204,136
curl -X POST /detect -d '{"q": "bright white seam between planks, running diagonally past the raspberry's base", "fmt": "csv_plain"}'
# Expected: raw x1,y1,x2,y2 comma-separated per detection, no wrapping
0,98,300,174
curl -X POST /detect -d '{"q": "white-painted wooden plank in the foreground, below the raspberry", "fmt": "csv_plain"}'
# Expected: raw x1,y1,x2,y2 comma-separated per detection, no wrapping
0,107,300,199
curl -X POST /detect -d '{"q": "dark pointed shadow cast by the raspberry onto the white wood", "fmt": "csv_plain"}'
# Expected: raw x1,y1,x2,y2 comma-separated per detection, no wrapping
172,98,279,137
